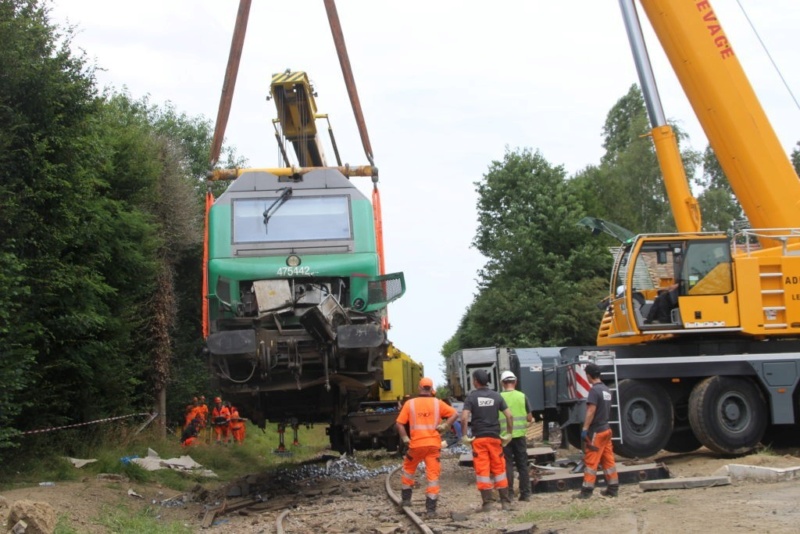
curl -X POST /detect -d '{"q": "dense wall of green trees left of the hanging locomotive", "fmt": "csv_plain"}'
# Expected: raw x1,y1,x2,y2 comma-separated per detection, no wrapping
0,0,238,456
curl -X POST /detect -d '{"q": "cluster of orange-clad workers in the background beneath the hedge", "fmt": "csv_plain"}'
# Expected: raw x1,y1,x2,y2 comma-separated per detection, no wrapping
181,395,245,447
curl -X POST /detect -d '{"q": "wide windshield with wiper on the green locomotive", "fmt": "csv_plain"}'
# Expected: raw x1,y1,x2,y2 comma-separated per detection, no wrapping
233,196,351,243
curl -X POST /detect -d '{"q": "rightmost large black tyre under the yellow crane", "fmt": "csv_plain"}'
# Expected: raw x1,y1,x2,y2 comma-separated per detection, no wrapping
689,376,768,456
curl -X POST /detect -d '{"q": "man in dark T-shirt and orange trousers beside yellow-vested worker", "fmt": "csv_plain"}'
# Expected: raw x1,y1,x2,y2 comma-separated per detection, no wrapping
461,369,514,512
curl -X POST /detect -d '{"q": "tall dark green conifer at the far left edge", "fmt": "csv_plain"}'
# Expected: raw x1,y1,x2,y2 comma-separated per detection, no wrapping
0,0,162,448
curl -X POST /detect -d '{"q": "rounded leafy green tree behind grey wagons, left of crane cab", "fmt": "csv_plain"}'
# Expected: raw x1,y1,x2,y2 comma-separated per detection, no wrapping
446,150,610,351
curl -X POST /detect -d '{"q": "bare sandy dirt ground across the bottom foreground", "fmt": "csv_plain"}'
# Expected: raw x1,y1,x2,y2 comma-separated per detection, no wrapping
0,449,800,534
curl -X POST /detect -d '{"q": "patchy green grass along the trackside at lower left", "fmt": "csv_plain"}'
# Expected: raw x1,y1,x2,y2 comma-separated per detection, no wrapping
0,425,336,534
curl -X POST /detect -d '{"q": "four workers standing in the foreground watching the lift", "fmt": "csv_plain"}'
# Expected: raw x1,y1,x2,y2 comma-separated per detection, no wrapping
396,364,619,517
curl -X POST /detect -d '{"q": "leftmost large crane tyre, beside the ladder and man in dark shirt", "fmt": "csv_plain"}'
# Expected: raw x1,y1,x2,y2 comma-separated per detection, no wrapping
612,380,673,458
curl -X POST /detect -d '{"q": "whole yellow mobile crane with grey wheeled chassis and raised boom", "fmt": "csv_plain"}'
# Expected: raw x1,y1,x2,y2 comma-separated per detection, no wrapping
450,0,800,457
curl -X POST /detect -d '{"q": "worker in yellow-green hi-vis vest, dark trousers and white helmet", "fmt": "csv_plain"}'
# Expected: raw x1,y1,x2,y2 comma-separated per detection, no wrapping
500,371,533,501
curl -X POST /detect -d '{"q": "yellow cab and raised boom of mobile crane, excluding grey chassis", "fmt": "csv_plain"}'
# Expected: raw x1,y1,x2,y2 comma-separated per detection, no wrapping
598,0,800,345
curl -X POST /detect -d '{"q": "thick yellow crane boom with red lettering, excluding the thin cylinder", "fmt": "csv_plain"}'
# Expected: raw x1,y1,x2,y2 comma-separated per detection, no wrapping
640,0,800,232
